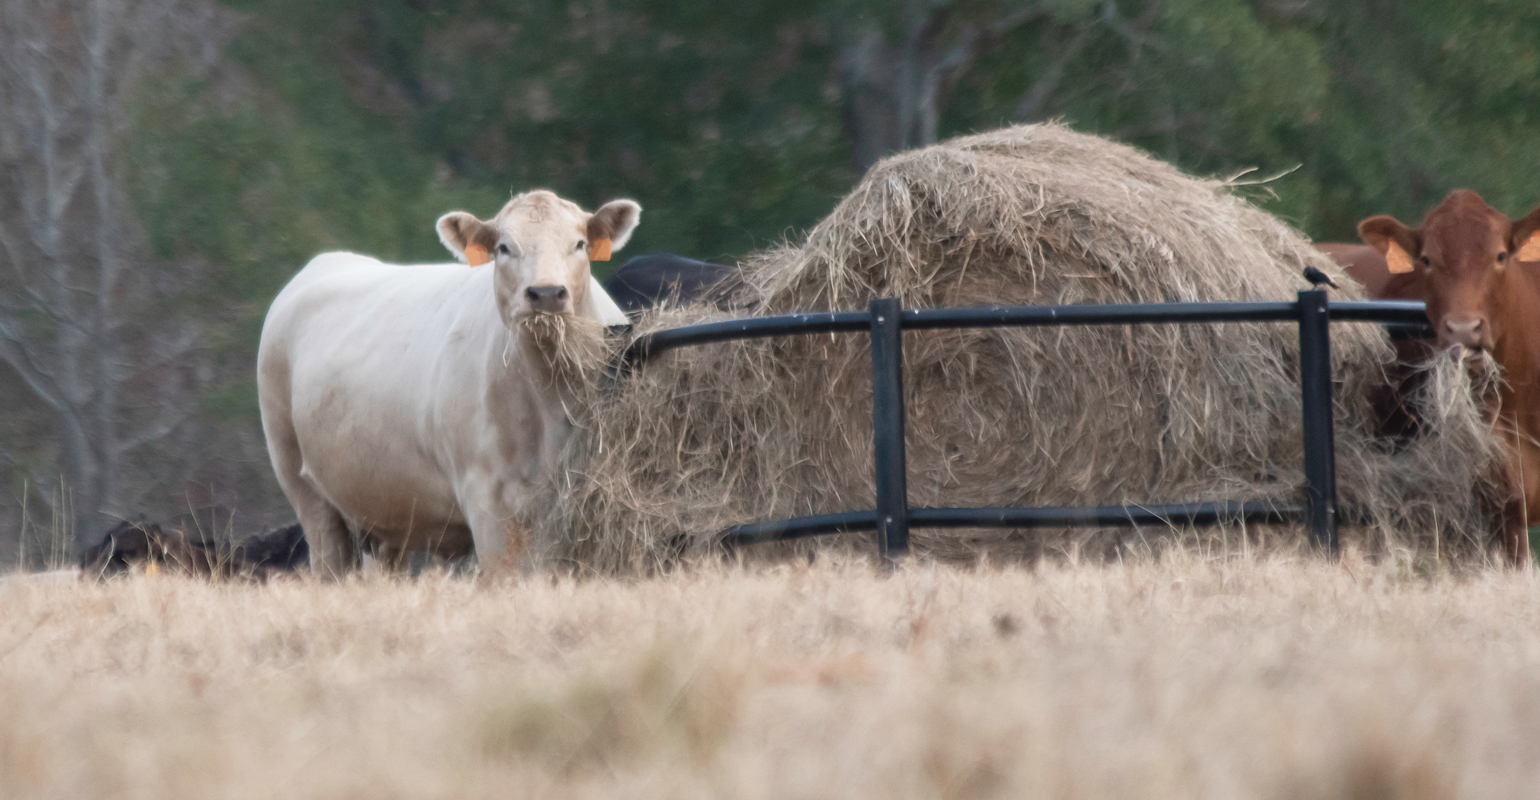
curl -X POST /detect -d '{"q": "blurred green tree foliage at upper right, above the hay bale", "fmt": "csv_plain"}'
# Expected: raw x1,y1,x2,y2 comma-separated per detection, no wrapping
941,0,1540,239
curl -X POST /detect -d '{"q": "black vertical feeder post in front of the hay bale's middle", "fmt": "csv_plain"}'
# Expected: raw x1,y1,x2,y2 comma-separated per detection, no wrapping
870,297,909,561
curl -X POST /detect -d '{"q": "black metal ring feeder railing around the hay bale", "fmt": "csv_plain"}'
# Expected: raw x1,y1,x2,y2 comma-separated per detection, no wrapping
624,290,1428,560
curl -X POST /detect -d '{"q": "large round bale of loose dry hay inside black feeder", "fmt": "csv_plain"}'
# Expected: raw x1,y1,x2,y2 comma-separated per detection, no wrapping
537,125,1494,572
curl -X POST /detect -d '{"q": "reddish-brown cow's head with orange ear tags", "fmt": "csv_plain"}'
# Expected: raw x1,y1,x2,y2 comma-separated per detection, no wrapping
1358,190,1540,361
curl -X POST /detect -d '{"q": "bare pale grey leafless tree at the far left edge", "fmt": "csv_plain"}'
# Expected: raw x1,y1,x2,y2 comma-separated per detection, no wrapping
0,0,234,545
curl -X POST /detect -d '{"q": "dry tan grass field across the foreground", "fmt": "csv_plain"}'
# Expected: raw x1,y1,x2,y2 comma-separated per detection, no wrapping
0,552,1540,798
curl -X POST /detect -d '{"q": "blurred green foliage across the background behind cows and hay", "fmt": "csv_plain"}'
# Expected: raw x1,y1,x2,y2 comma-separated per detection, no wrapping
134,0,1540,289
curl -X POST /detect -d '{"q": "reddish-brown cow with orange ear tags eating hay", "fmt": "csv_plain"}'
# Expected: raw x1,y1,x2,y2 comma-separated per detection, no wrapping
1358,190,1540,564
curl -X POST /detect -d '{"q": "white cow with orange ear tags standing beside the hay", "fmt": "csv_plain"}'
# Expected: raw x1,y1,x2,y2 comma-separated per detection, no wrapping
257,191,642,575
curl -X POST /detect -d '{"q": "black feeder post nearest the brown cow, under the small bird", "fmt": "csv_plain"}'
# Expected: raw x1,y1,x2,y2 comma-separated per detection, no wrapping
1300,290,1337,555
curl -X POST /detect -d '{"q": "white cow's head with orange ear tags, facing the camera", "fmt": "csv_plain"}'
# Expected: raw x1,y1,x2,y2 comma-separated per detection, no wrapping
437,190,642,328
